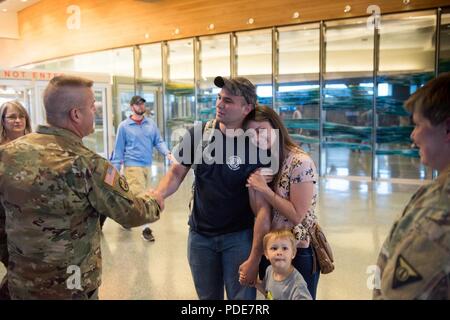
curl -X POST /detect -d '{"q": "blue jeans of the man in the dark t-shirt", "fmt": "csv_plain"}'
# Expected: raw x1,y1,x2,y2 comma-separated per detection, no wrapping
188,229,256,300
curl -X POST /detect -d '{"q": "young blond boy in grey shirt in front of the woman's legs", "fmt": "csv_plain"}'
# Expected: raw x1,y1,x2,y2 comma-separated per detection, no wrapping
255,230,312,300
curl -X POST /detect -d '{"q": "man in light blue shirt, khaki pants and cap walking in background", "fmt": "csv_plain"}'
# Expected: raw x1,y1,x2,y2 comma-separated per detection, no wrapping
106,96,172,241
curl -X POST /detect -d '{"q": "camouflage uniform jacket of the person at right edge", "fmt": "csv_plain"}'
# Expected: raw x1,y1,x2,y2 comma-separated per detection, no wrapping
374,167,450,299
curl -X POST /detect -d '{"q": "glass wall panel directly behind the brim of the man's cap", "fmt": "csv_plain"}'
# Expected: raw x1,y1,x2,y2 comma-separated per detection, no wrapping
197,34,230,122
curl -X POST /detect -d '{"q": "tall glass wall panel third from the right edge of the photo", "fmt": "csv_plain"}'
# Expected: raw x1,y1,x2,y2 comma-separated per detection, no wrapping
323,19,374,176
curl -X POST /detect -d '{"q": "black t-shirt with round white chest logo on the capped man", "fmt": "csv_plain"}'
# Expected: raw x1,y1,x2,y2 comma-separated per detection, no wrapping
174,122,268,236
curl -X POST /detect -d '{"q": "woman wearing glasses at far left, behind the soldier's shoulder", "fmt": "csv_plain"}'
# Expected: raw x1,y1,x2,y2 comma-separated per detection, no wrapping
0,101,31,145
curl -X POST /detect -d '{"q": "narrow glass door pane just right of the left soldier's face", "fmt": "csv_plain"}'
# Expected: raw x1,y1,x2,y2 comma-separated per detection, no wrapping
83,88,108,158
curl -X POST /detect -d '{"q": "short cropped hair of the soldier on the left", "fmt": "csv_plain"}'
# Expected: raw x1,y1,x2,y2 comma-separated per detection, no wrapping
44,75,94,125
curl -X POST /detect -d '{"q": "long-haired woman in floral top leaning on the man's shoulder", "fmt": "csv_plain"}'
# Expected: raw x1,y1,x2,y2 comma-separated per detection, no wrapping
244,106,320,299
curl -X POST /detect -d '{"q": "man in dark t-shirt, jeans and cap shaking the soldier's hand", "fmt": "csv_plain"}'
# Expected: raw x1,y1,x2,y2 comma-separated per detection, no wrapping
151,77,270,299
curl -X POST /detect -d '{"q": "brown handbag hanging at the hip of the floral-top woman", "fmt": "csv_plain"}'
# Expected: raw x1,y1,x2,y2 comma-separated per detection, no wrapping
308,223,334,274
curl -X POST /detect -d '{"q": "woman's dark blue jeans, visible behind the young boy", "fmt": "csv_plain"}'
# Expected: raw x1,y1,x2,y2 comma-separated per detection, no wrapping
259,246,320,300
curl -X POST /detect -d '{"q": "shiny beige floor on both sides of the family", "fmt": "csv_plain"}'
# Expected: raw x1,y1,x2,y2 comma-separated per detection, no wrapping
0,167,418,299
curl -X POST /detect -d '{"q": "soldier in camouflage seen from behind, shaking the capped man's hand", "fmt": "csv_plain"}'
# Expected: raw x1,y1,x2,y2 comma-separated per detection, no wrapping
0,76,162,299
